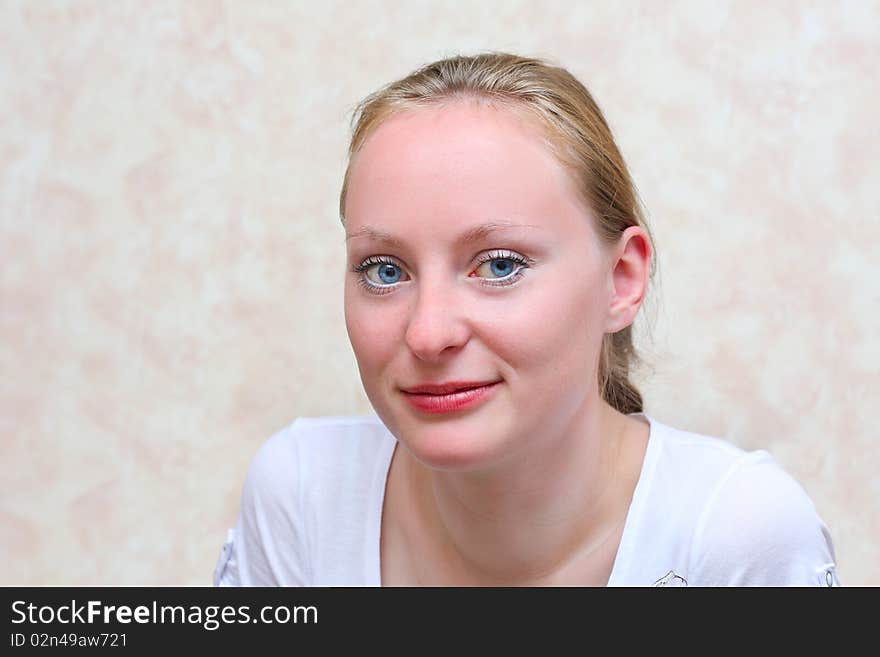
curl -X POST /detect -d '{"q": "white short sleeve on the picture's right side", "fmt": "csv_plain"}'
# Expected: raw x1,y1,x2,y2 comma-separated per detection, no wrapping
689,450,840,586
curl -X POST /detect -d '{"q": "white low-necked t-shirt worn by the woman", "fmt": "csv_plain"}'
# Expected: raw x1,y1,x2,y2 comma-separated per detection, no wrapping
214,413,839,586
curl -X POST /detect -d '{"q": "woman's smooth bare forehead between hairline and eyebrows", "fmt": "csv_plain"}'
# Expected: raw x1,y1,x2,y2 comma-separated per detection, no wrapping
346,102,589,247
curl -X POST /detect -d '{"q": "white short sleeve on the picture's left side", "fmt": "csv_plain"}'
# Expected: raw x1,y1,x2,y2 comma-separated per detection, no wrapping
214,422,307,586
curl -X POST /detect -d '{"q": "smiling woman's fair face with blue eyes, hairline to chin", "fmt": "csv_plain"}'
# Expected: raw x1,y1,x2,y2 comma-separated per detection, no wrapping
345,102,616,470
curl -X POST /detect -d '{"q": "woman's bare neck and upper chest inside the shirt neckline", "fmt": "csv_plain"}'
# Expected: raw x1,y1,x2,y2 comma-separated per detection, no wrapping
407,398,635,586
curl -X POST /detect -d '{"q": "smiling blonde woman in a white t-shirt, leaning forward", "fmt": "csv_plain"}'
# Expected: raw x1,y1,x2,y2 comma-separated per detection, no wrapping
214,53,838,586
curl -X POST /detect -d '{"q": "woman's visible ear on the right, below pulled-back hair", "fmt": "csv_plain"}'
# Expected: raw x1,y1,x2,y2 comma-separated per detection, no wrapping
605,226,651,333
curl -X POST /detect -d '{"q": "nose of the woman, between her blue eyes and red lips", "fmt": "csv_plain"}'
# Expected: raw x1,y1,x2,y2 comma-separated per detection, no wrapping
405,282,469,361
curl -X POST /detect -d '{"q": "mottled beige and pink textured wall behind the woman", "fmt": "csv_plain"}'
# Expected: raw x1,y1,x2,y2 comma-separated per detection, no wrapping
0,0,880,585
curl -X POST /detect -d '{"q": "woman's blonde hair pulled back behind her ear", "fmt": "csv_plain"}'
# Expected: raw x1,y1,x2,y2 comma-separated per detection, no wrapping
339,51,656,413
